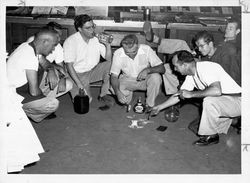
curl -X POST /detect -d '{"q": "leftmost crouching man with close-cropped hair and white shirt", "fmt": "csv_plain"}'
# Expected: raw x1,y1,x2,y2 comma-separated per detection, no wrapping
7,29,72,122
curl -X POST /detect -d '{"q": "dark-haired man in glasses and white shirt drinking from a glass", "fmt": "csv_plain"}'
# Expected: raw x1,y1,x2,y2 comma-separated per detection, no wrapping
63,14,112,107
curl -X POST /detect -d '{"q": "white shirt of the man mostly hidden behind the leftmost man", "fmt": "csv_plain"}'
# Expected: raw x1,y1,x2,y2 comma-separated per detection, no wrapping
27,36,64,64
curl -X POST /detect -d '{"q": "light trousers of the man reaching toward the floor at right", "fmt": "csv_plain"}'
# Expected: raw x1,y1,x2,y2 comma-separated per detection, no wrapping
198,95,241,135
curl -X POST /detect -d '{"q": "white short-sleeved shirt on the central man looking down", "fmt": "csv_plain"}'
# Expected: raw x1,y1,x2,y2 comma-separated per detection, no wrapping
110,44,162,78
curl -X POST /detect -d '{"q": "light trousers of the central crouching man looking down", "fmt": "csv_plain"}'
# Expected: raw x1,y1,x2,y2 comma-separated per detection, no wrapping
119,73,162,107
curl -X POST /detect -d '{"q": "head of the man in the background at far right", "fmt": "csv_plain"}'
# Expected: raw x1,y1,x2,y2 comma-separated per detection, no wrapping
224,19,241,41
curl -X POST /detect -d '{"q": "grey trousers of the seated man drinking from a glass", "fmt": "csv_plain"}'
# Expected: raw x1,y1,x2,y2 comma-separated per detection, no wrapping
70,61,111,100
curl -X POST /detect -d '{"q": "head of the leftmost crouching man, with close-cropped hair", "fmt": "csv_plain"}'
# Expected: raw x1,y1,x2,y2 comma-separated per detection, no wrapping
34,29,59,56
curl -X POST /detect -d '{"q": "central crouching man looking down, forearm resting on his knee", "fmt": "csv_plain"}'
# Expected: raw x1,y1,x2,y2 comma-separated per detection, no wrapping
110,34,165,112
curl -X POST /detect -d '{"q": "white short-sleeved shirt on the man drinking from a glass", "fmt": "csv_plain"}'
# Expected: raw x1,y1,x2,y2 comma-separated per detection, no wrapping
63,32,106,73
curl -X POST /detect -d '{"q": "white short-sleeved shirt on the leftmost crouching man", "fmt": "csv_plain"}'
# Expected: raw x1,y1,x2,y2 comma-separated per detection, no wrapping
7,42,39,88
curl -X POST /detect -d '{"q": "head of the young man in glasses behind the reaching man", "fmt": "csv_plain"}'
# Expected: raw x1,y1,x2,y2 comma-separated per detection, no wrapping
195,31,214,56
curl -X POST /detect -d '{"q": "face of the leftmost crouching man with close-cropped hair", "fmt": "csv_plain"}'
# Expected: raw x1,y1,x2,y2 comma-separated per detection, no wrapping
43,34,59,56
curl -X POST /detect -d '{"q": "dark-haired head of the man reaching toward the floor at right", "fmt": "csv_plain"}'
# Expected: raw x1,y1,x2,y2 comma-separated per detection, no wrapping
172,50,195,75
